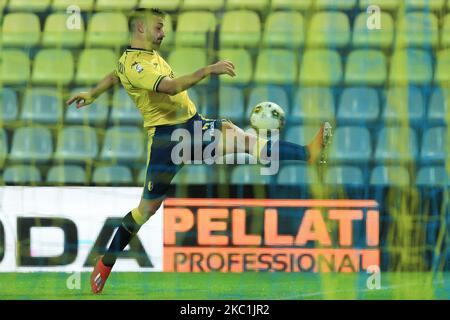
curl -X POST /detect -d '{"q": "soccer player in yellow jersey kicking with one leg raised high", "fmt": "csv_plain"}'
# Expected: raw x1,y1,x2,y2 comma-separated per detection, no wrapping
67,9,332,293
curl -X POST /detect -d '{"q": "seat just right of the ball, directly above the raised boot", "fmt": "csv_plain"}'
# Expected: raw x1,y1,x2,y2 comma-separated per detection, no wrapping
291,87,336,123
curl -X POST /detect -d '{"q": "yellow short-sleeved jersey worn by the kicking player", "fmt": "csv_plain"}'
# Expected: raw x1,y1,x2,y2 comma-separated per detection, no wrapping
116,48,197,128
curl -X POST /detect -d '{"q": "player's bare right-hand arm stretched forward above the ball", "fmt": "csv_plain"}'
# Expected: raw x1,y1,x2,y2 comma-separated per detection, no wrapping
155,60,236,96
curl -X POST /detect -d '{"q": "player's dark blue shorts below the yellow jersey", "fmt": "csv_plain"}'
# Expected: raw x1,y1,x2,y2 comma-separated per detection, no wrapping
143,113,227,200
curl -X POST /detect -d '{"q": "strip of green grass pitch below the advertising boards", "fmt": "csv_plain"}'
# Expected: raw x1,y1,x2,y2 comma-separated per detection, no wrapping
0,272,450,300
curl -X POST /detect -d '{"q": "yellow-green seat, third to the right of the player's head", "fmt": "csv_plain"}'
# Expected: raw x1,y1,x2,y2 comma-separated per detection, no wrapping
262,11,305,48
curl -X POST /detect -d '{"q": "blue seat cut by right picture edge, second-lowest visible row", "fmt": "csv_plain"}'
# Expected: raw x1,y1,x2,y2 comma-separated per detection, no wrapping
420,127,450,163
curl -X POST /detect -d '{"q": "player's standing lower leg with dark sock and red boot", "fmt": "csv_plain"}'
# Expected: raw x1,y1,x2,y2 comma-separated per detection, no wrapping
90,199,162,294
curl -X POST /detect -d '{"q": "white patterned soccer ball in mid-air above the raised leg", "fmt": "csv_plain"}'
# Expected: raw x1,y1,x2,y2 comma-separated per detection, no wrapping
250,102,285,130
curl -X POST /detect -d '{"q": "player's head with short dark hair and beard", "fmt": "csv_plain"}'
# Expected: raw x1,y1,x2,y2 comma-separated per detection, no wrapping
129,8,166,49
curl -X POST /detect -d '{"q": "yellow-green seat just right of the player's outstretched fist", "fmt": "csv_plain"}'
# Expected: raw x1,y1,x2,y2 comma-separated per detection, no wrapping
253,49,298,85
